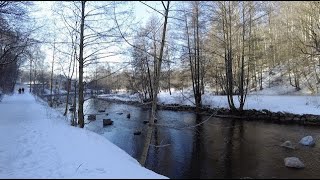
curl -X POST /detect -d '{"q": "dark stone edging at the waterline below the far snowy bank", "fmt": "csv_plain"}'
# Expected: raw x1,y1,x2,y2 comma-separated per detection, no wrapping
98,97,320,126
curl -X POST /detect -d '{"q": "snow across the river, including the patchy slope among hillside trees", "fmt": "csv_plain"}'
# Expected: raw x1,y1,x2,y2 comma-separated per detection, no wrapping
95,65,320,115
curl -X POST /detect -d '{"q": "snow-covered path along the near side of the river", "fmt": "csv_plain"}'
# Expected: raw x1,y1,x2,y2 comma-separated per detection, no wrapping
0,93,166,178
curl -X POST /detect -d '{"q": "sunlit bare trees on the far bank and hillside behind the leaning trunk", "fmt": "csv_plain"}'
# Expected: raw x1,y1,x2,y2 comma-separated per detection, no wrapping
131,1,320,111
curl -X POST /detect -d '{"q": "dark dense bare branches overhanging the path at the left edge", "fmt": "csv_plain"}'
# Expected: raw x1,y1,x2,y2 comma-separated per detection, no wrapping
0,1,38,93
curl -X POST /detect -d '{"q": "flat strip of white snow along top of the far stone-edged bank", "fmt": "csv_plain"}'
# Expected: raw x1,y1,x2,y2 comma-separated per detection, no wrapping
99,89,320,115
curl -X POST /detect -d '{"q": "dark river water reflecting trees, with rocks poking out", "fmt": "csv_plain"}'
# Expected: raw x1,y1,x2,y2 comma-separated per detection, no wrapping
53,99,320,179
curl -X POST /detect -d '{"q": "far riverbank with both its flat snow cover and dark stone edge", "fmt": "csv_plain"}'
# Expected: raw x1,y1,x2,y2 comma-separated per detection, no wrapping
98,93,320,126
